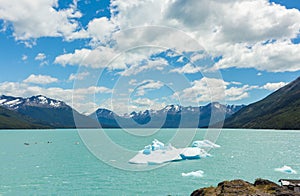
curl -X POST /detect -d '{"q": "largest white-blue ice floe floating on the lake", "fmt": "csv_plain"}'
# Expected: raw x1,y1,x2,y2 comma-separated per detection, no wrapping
129,139,218,165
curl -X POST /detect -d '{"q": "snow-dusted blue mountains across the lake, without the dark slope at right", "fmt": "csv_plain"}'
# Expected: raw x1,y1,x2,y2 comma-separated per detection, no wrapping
0,95,244,128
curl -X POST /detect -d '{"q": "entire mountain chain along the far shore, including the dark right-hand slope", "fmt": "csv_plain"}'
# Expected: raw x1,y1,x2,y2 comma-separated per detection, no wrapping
0,77,300,129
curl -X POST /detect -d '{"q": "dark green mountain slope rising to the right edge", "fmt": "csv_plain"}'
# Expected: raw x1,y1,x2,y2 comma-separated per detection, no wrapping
224,77,300,129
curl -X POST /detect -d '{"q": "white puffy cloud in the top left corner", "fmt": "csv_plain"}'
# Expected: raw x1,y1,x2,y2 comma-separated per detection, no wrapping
0,0,82,40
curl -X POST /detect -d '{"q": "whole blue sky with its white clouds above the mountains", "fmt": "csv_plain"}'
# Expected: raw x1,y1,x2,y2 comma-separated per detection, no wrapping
0,0,300,114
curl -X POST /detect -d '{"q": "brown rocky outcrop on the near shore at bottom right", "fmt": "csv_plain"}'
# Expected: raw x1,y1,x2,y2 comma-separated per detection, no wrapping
191,179,300,196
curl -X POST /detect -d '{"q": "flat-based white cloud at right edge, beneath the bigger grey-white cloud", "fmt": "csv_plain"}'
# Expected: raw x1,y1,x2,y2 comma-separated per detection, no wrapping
214,40,300,72
